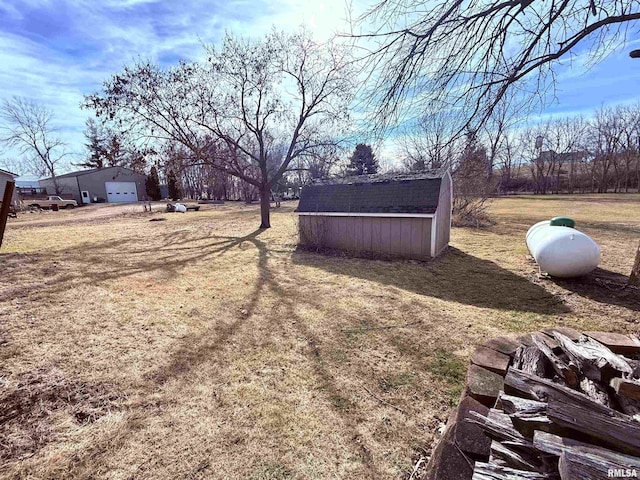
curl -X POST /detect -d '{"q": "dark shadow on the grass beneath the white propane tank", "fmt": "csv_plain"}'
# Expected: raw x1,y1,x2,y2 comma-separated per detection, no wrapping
552,268,640,312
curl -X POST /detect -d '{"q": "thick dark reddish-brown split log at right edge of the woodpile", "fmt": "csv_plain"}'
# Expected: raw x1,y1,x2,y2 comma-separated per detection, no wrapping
547,398,640,456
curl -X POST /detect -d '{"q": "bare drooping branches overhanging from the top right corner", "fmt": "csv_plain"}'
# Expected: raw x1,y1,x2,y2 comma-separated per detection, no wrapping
356,0,640,128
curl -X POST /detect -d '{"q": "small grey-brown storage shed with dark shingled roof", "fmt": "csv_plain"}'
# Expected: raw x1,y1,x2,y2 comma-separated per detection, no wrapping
296,170,453,259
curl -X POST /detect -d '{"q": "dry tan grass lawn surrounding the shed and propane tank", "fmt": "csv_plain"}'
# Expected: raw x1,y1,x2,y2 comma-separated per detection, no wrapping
0,195,640,479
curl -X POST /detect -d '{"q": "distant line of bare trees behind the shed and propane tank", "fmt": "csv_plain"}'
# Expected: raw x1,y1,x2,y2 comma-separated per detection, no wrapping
401,104,640,194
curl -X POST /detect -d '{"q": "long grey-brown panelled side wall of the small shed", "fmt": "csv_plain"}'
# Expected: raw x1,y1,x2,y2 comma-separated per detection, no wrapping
298,215,432,259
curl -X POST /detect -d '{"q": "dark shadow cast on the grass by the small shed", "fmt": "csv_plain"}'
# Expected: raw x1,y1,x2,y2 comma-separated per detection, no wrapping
292,247,570,314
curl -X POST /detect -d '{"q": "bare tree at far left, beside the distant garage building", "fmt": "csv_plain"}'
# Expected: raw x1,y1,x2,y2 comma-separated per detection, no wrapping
0,97,67,195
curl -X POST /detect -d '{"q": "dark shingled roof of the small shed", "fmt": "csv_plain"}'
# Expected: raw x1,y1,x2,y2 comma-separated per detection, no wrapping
296,172,443,214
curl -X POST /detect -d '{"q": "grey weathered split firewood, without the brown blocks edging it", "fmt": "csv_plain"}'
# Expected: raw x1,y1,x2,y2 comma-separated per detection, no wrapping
466,331,640,480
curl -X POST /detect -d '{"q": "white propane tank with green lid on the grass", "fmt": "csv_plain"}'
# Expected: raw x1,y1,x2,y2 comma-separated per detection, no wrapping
526,220,600,278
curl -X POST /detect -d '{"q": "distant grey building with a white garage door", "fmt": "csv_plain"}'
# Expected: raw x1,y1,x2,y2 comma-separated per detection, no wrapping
39,167,147,203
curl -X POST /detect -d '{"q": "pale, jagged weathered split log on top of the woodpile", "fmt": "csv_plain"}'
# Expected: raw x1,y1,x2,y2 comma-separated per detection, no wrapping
553,332,633,382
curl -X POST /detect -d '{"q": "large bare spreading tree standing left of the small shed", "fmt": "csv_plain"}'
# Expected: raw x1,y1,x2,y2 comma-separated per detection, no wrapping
86,31,355,228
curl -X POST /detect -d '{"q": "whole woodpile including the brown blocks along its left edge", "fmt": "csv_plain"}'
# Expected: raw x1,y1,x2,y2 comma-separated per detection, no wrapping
423,328,640,480
